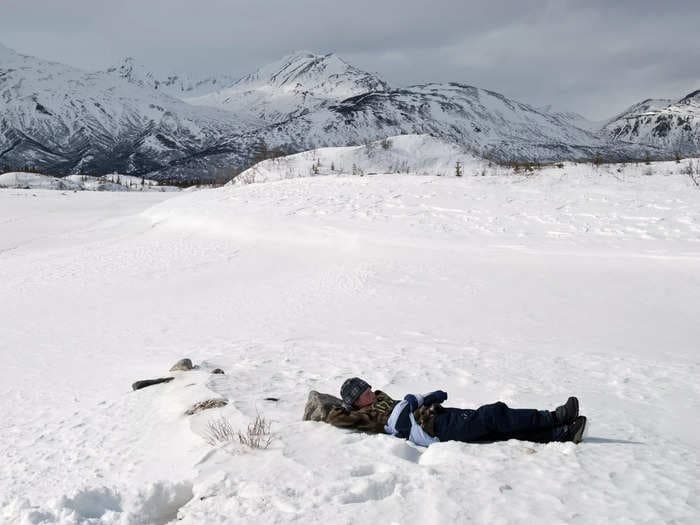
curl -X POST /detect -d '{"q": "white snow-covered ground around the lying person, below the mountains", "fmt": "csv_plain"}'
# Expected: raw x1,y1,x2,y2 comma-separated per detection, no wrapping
0,169,700,524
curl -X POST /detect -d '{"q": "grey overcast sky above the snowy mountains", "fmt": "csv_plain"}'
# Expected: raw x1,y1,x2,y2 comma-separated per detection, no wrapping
0,0,700,120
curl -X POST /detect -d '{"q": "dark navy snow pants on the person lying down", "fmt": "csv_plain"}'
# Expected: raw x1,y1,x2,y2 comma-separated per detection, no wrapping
434,401,566,443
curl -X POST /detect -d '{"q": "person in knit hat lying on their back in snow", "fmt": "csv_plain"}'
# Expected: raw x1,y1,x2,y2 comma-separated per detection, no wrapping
326,377,586,447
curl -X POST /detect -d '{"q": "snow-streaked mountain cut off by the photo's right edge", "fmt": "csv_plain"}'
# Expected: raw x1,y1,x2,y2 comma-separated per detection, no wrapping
602,90,700,155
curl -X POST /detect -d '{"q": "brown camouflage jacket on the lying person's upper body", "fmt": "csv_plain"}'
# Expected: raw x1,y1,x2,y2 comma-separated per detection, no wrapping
326,390,439,437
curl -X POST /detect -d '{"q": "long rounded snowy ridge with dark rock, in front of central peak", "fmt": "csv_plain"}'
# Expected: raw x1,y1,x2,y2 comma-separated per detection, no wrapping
230,82,652,165
